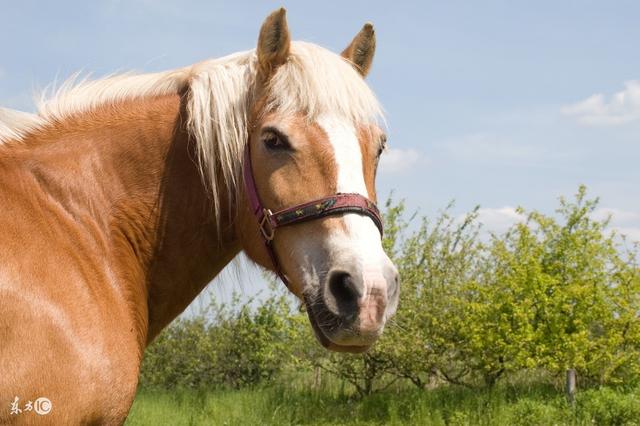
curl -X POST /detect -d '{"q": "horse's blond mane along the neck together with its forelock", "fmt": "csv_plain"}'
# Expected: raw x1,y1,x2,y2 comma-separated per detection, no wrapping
0,42,382,225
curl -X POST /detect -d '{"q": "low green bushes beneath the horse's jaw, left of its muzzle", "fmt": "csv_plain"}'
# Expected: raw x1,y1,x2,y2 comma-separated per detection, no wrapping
141,291,304,388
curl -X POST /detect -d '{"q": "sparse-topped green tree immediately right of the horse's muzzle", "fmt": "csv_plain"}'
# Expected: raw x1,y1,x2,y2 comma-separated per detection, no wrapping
381,203,480,388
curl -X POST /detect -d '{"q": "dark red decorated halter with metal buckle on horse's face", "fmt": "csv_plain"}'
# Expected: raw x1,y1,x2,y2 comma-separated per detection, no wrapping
242,144,383,287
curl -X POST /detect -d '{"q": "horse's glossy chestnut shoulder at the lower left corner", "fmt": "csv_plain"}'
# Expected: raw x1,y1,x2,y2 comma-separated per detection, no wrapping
0,162,140,424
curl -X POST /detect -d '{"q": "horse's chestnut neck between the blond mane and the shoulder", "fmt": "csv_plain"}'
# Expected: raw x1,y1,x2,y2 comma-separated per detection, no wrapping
18,95,240,348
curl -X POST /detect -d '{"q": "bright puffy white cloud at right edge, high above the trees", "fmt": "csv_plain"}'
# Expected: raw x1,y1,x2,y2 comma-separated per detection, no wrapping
560,80,640,126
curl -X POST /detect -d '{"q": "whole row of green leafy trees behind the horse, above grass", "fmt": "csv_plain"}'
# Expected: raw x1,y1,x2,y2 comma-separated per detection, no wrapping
141,187,640,395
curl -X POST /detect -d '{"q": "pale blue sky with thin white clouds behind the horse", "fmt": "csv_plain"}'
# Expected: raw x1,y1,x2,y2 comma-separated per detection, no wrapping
0,0,640,310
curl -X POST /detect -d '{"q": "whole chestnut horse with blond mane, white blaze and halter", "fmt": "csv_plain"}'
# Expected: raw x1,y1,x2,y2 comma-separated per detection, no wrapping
0,9,399,425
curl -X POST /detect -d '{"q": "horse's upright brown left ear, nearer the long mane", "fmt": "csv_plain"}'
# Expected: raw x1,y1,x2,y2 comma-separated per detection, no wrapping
257,7,291,78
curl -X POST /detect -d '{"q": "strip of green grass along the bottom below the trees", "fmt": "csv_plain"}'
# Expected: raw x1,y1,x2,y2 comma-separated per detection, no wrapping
126,385,640,426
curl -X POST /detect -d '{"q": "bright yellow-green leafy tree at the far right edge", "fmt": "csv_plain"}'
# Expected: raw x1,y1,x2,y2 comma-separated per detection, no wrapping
461,187,640,384
